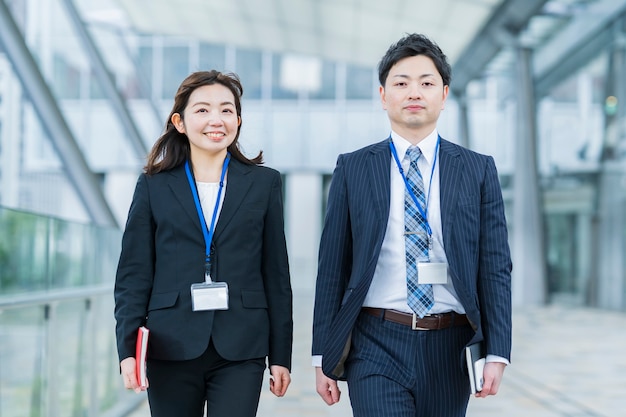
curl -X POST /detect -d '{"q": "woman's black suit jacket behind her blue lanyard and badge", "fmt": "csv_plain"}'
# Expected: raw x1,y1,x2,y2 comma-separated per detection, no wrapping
115,159,293,369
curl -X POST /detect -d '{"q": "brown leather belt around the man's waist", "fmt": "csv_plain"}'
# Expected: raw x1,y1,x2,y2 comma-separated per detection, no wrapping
361,307,470,330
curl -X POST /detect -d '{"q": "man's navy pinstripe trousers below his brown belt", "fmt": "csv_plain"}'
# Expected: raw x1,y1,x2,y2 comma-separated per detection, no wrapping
346,313,474,417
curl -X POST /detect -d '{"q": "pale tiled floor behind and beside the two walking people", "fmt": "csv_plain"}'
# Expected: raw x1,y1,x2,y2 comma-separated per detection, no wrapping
131,291,626,417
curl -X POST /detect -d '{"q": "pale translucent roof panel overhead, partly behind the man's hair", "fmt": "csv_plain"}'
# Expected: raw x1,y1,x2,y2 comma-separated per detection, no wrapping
118,0,502,66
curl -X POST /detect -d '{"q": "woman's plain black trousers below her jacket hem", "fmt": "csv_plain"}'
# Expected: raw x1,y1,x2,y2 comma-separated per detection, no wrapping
147,342,265,417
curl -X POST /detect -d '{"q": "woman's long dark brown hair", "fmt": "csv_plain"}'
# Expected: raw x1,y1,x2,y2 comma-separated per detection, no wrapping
144,70,263,175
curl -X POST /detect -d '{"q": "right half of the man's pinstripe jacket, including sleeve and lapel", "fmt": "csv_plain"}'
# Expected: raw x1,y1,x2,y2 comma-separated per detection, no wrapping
439,140,512,360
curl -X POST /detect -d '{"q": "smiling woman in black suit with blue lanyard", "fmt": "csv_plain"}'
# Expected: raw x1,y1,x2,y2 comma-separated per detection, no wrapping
115,71,293,417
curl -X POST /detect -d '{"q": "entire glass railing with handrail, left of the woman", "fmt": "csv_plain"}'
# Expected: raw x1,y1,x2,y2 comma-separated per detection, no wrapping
0,207,139,417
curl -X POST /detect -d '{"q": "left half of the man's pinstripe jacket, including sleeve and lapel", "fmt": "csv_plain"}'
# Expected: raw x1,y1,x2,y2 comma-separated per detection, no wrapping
313,141,391,378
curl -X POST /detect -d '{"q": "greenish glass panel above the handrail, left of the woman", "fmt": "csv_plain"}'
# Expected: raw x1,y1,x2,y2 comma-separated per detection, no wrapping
0,207,121,295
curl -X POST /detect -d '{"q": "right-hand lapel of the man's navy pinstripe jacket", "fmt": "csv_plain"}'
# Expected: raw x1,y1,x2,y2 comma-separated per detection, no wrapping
439,139,461,252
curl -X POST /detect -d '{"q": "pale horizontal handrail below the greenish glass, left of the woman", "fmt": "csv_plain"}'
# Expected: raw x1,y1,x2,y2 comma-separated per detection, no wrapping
0,284,113,310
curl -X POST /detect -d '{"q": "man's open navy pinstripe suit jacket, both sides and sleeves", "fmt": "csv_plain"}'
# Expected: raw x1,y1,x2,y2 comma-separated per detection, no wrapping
312,139,511,395
